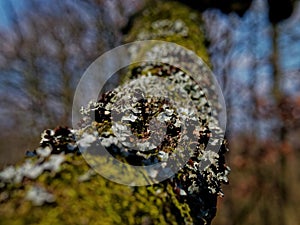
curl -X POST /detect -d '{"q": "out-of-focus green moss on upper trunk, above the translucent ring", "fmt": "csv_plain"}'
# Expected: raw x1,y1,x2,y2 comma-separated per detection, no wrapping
125,1,210,64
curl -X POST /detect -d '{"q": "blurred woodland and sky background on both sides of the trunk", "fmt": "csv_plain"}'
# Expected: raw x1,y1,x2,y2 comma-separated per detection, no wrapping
0,0,300,225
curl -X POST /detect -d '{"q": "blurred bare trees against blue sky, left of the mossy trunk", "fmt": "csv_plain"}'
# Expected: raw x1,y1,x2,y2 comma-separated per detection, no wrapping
0,0,120,165
